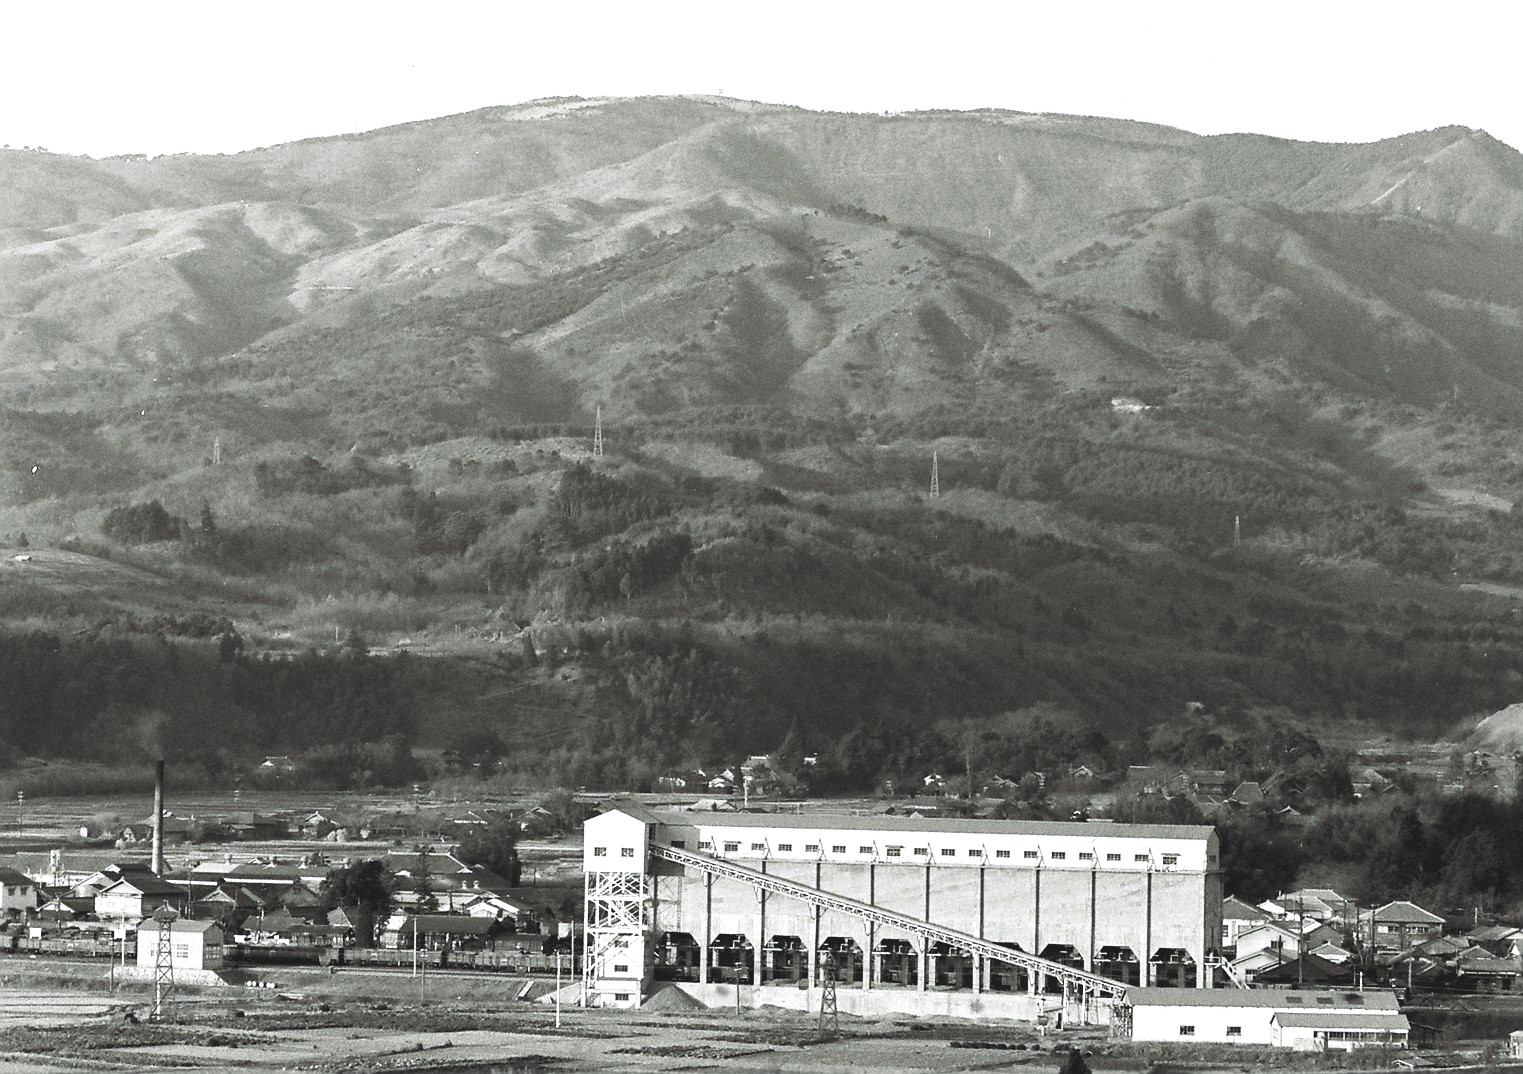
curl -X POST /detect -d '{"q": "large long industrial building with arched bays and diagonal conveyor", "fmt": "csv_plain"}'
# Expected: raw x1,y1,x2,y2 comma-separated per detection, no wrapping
583,804,1221,1021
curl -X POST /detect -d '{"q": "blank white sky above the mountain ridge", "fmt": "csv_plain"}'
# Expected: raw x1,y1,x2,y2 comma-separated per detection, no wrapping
11,0,1523,157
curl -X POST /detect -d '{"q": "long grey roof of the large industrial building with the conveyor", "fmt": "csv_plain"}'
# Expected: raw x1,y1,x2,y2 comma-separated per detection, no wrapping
636,806,1215,841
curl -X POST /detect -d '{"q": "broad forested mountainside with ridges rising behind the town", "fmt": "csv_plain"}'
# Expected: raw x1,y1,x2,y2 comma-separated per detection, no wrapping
0,99,1523,788
